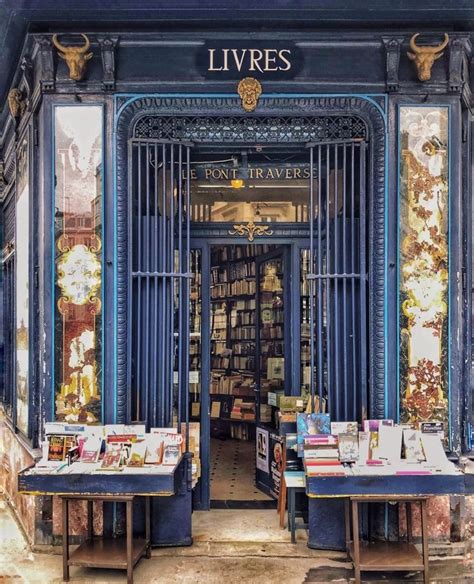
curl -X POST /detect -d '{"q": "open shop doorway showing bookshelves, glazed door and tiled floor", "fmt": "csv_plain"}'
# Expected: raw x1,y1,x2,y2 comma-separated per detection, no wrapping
190,244,293,508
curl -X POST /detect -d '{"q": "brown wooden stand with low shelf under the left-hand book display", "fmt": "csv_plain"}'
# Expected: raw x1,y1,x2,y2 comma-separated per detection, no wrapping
60,495,151,584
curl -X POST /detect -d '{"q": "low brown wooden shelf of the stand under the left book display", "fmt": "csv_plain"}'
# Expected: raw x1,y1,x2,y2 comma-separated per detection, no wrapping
68,537,148,570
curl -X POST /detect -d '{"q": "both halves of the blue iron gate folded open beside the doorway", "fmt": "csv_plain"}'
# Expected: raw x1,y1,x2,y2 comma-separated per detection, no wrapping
128,120,368,438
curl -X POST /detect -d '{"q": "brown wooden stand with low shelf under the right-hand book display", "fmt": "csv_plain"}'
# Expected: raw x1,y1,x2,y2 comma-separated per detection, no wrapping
346,495,429,584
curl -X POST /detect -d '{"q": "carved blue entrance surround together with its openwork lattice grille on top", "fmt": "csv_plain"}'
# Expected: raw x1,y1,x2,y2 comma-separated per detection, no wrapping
115,96,386,422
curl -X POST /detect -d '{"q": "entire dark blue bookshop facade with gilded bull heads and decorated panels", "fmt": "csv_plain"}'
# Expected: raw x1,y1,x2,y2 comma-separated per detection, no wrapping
0,4,473,547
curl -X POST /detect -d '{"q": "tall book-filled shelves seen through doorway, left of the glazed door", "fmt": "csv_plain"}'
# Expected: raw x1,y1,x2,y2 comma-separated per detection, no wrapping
209,245,280,440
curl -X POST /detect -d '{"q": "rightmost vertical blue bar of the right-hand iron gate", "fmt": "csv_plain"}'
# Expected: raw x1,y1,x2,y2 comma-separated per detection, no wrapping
359,142,368,422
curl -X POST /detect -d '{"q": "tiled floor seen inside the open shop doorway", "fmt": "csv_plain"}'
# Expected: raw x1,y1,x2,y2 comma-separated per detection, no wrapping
211,438,271,501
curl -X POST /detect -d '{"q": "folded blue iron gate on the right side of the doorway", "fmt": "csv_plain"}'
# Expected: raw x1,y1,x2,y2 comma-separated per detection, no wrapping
308,140,368,421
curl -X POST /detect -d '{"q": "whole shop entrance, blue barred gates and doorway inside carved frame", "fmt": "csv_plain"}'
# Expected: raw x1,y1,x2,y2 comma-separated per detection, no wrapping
128,118,368,509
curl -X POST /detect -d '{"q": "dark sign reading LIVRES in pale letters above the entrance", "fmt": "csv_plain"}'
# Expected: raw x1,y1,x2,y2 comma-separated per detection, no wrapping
197,40,303,79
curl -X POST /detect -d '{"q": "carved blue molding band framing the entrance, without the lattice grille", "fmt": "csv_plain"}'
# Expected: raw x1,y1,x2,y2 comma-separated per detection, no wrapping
115,96,386,423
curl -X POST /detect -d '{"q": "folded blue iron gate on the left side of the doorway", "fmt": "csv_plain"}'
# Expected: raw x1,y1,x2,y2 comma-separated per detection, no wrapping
128,140,192,450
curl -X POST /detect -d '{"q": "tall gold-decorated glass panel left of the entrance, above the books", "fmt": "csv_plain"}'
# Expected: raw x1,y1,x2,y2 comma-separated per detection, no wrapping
54,106,103,424
